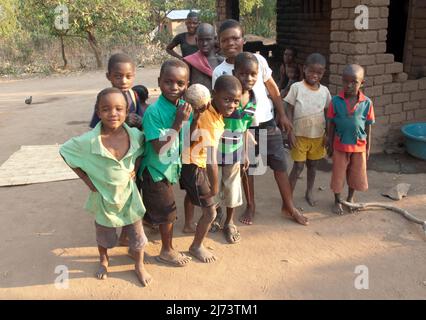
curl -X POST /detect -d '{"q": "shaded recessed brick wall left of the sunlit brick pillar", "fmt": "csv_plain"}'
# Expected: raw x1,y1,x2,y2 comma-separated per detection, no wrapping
277,0,331,83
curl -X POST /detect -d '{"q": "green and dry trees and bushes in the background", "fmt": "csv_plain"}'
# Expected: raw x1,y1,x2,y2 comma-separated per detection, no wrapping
0,0,276,74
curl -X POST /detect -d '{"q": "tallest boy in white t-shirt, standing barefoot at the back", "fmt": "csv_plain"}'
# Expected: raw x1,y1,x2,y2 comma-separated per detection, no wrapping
213,19,308,225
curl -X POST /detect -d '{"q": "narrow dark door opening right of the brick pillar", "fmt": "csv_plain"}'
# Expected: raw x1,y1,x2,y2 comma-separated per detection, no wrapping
386,0,410,62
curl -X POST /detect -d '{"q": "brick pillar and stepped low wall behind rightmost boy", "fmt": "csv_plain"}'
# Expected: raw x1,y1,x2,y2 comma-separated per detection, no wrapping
329,0,426,152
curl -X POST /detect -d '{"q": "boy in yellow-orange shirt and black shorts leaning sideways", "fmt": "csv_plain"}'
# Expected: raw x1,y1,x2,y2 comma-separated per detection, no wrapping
180,75,241,263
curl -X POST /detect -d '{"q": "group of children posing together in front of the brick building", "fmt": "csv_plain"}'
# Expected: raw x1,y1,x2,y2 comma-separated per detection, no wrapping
60,20,374,286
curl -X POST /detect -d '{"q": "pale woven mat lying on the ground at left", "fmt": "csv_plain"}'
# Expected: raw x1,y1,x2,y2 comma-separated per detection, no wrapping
0,145,78,187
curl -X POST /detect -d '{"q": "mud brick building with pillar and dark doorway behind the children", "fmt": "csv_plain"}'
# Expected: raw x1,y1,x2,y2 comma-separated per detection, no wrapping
217,0,426,152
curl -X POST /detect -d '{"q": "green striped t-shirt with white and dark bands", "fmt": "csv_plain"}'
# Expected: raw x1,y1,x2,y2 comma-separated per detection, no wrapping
218,90,256,165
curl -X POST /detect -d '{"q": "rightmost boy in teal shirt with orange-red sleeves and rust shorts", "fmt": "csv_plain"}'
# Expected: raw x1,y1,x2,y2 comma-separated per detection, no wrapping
327,64,374,214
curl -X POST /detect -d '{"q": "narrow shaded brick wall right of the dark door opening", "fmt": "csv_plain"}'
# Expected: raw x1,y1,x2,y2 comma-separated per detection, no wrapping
404,0,426,79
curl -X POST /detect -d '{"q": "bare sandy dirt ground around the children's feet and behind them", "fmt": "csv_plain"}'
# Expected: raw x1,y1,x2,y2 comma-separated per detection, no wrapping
0,68,426,299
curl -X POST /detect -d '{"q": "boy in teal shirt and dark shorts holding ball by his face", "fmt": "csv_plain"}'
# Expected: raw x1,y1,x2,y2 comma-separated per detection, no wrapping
138,60,192,267
